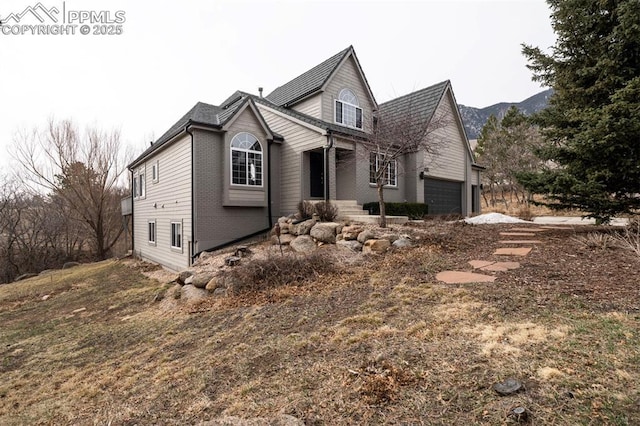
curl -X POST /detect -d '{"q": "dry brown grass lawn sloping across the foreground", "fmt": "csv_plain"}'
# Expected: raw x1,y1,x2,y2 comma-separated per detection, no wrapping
0,230,640,425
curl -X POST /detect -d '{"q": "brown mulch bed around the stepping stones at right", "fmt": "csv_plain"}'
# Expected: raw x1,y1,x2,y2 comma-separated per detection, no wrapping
424,224,640,313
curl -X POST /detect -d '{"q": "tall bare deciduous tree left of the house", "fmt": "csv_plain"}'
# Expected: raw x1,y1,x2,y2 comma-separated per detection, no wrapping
13,120,129,259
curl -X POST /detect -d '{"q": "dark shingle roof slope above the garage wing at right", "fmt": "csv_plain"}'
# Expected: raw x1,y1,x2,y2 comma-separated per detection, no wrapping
379,80,451,120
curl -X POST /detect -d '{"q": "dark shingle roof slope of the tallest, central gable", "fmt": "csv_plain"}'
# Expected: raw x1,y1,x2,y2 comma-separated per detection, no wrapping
267,46,353,106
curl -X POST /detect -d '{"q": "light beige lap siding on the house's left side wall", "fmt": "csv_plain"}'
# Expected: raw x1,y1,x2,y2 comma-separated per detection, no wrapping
133,135,191,271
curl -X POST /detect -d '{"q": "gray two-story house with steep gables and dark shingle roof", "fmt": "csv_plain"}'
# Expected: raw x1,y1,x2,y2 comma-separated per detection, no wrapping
129,47,480,270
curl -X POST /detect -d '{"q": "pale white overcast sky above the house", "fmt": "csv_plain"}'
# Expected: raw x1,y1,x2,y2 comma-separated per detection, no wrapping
0,0,555,172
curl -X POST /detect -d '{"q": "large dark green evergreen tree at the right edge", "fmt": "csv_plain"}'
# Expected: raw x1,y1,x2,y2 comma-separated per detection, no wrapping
519,0,640,222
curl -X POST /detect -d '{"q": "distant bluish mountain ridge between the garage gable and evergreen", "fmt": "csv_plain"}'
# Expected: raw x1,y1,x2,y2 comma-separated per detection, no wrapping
458,89,553,139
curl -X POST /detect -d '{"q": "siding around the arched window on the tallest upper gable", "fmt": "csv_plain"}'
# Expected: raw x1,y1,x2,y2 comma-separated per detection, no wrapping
322,56,373,132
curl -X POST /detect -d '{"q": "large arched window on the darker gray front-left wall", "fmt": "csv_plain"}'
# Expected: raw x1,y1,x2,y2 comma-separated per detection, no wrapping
231,132,262,186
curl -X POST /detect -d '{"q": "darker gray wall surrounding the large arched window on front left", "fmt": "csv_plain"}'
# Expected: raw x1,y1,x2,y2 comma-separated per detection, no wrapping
194,108,270,252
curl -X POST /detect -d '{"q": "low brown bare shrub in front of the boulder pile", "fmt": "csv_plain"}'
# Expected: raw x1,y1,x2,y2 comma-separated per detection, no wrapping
228,253,335,293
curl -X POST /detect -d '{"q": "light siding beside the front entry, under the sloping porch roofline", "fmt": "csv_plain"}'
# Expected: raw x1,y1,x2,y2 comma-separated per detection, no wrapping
258,104,327,214
